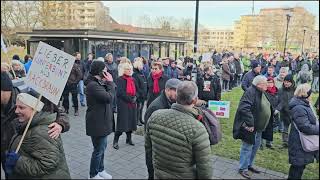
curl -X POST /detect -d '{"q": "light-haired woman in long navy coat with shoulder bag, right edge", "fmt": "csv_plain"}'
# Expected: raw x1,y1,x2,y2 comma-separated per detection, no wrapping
288,84,319,179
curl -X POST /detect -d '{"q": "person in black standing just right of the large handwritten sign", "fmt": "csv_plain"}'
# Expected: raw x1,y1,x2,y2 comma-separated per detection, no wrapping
62,52,82,116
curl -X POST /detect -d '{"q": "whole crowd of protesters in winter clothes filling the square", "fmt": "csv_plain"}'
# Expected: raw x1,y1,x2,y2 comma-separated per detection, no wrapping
1,48,319,179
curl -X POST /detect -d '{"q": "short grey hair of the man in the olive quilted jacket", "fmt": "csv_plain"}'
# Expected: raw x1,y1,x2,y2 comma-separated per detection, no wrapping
177,81,198,105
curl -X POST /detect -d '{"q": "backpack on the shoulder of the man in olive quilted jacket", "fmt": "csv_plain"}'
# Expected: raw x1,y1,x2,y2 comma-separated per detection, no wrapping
195,107,222,145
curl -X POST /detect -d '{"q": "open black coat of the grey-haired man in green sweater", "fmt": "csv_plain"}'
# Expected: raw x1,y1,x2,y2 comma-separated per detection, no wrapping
233,85,273,144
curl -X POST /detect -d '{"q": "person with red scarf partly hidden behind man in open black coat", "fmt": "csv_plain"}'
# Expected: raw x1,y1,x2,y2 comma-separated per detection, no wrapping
261,77,279,149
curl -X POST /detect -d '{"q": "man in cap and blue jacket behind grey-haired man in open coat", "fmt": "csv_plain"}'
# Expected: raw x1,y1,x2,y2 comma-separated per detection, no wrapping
241,60,261,91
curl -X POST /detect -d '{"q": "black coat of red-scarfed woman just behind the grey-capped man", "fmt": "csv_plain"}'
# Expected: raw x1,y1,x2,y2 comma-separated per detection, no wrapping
147,74,169,107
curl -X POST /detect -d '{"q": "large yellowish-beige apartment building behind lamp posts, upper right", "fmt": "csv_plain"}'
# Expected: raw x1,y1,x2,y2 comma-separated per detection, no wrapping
234,7,317,52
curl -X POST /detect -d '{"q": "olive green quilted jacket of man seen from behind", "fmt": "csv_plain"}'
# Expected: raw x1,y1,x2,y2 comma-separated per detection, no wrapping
145,104,213,179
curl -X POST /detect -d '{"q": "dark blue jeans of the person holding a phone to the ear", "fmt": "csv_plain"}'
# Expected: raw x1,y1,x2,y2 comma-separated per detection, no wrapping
90,136,107,178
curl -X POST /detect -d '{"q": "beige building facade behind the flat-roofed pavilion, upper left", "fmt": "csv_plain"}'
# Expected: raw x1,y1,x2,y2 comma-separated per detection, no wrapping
41,1,111,30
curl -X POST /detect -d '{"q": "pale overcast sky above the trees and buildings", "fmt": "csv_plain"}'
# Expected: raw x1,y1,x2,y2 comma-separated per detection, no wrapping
103,1,319,29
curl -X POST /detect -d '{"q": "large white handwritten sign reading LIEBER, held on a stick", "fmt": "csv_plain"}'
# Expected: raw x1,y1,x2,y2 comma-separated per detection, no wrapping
25,42,75,105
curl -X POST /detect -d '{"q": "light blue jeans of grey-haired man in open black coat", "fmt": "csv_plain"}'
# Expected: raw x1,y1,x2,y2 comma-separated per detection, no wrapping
239,132,262,171
